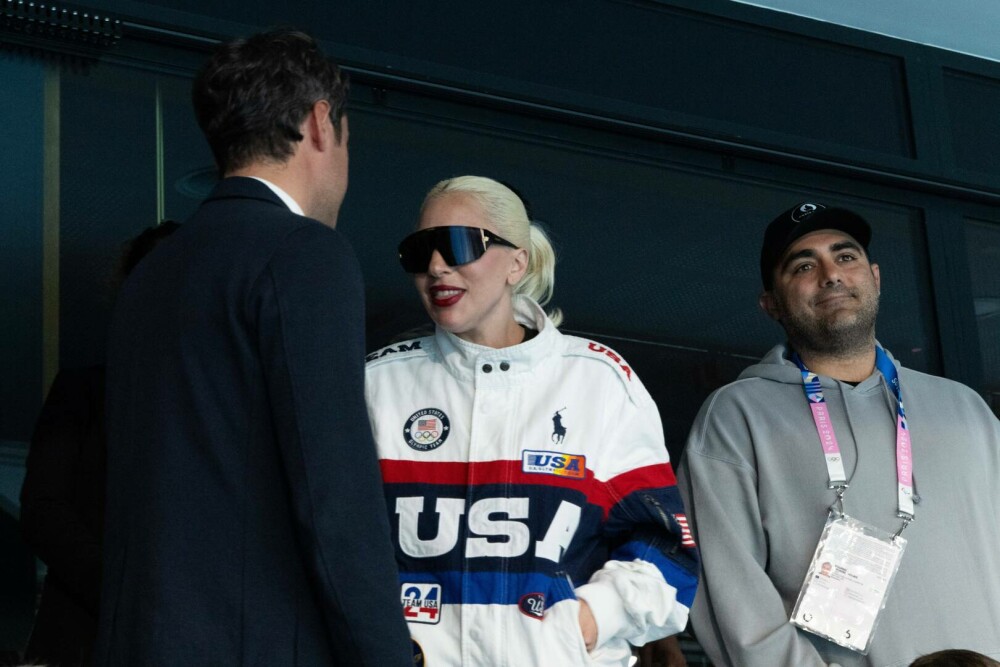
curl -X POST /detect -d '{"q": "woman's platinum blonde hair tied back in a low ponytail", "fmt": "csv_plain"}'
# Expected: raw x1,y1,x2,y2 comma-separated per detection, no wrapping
420,176,563,326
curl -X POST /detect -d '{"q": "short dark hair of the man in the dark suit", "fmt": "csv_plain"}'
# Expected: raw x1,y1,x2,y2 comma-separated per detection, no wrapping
191,29,349,174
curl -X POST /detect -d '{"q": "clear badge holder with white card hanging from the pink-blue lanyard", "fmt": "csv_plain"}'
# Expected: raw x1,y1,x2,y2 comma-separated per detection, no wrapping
790,512,906,655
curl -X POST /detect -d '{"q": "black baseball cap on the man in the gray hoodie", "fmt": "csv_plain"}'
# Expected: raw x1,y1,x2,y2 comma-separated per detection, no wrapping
760,202,872,290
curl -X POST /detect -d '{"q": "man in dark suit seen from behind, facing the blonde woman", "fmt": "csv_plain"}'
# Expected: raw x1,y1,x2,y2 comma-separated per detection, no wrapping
96,31,412,667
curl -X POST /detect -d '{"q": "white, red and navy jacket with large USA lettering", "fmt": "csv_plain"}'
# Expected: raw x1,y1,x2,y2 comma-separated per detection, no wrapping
366,297,698,667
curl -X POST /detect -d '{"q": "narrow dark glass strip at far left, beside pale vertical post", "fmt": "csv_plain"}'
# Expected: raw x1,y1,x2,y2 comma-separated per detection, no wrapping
0,45,49,656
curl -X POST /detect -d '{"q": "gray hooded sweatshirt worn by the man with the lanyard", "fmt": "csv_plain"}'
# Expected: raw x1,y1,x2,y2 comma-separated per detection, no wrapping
679,345,1000,667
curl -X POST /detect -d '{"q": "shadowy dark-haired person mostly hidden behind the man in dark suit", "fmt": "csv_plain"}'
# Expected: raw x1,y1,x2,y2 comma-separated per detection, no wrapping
21,220,178,667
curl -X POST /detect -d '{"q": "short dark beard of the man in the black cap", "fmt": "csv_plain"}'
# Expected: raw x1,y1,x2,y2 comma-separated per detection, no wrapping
775,288,879,358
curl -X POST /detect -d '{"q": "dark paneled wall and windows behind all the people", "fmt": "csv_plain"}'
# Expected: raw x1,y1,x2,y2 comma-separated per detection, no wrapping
0,0,1000,649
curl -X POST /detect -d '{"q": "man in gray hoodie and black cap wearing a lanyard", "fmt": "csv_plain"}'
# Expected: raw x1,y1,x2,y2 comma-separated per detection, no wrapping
679,203,1000,667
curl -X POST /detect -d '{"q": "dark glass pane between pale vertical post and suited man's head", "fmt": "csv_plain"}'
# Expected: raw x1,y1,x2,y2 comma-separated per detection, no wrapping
60,65,212,367
